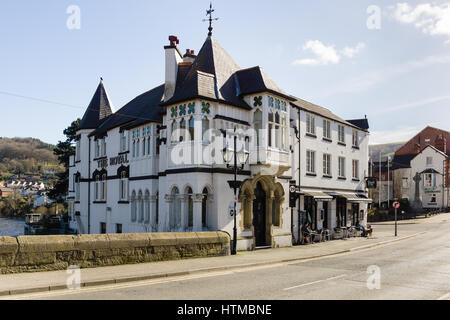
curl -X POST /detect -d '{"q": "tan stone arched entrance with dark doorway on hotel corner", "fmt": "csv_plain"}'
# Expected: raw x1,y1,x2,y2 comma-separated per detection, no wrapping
239,175,284,249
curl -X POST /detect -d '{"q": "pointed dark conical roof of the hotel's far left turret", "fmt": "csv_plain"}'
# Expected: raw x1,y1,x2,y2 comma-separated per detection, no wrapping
78,80,112,130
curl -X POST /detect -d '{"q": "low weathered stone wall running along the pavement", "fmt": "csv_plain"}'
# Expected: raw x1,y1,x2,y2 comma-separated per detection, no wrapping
0,231,230,274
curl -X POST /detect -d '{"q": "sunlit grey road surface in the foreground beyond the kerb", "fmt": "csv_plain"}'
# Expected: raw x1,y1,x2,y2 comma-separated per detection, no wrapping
10,221,450,300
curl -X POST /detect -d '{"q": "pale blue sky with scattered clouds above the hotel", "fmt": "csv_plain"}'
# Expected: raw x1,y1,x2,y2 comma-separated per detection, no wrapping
0,0,450,144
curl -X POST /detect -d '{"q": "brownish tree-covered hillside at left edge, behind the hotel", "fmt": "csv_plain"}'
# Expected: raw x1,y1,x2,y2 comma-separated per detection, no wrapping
0,137,63,180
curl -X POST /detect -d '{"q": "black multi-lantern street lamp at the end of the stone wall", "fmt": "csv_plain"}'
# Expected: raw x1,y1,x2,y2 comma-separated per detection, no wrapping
222,127,250,255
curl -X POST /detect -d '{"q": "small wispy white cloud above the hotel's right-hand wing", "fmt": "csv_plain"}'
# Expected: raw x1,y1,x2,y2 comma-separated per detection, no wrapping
293,40,365,66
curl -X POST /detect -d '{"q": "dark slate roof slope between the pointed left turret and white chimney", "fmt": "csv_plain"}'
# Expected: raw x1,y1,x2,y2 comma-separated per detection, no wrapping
90,85,164,136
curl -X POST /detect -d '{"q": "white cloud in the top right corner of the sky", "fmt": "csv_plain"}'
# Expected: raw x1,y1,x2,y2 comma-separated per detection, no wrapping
389,2,450,40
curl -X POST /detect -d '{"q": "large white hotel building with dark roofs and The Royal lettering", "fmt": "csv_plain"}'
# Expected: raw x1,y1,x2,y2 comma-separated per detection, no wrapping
69,30,370,250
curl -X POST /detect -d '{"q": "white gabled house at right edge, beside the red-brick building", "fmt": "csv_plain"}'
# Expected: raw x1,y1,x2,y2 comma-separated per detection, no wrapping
397,145,449,209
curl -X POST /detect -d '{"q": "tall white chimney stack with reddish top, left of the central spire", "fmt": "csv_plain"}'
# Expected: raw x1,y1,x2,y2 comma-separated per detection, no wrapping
164,36,183,101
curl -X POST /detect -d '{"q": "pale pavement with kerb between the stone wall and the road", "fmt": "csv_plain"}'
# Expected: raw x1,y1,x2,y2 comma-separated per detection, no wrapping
0,213,450,299
